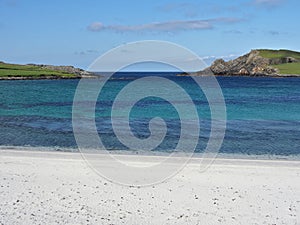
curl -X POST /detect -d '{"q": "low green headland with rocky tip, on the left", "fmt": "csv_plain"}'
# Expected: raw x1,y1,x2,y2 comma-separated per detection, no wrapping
0,62,95,80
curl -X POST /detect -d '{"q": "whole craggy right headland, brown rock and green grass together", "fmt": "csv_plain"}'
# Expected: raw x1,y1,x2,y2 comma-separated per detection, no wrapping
183,49,300,77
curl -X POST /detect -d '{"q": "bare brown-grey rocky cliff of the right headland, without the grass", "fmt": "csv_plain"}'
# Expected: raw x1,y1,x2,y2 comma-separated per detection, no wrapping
195,50,297,76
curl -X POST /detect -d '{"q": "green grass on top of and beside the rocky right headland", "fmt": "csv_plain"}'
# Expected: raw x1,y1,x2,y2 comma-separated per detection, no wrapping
259,49,300,74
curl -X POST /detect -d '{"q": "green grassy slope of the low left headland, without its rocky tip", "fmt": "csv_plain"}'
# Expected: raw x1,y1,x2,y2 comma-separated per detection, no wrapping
0,62,76,78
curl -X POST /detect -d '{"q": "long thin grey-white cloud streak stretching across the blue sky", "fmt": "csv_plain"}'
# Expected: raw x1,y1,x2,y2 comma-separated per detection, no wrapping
87,17,241,32
